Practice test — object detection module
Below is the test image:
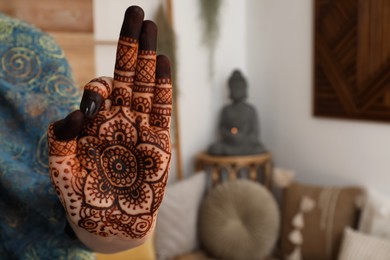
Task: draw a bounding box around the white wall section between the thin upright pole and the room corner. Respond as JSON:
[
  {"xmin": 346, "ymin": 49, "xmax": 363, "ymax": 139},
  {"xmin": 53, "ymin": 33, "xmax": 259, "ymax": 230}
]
[{"xmin": 173, "ymin": 0, "xmax": 246, "ymax": 175}]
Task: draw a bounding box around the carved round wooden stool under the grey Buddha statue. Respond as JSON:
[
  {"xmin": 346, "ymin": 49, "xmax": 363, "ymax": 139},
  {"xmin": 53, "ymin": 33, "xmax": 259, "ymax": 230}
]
[{"xmin": 195, "ymin": 152, "xmax": 272, "ymax": 189}]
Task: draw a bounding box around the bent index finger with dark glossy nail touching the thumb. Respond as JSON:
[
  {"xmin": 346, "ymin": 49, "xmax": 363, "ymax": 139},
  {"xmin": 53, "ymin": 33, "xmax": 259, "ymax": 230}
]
[{"xmin": 80, "ymin": 77, "xmax": 113, "ymax": 118}]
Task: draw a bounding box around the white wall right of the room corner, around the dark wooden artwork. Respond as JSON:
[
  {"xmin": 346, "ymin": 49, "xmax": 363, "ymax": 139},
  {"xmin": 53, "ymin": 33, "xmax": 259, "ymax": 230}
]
[{"xmin": 246, "ymin": 0, "xmax": 390, "ymax": 194}]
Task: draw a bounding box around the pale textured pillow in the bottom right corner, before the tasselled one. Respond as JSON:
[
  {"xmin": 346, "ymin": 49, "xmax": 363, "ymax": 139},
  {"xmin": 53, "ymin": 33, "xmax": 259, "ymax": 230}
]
[{"xmin": 338, "ymin": 228, "xmax": 390, "ymax": 260}]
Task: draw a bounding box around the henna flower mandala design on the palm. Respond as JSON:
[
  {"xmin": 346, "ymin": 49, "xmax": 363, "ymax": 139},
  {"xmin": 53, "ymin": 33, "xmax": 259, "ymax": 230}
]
[{"xmin": 77, "ymin": 107, "xmax": 170, "ymax": 238}]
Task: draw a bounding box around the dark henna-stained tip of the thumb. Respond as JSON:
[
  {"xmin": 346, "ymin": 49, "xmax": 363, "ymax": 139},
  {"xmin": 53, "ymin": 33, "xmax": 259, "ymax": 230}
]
[{"xmin": 52, "ymin": 110, "xmax": 84, "ymax": 141}]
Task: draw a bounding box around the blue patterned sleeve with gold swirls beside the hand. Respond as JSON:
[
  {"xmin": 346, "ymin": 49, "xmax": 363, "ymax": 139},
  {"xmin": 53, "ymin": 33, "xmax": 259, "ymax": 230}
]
[{"xmin": 0, "ymin": 13, "xmax": 94, "ymax": 259}]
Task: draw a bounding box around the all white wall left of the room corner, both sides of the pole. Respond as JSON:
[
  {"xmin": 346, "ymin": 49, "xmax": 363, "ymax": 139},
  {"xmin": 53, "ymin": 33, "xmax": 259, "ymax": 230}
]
[{"xmin": 94, "ymin": 0, "xmax": 247, "ymax": 179}]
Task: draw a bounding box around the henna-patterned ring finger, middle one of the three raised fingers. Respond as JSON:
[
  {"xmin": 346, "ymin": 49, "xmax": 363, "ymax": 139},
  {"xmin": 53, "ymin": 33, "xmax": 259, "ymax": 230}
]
[{"xmin": 132, "ymin": 21, "xmax": 157, "ymax": 116}]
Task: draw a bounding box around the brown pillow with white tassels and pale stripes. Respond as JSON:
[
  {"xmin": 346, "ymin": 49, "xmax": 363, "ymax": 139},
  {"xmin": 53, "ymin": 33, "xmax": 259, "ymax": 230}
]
[{"xmin": 281, "ymin": 183, "xmax": 364, "ymax": 260}]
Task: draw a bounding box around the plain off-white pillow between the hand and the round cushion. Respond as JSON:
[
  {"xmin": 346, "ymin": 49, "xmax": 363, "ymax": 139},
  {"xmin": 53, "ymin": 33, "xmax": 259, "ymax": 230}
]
[{"xmin": 155, "ymin": 172, "xmax": 207, "ymax": 260}]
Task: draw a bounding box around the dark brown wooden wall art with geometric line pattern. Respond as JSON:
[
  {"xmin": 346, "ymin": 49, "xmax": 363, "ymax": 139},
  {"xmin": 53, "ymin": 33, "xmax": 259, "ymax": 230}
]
[{"xmin": 314, "ymin": 0, "xmax": 390, "ymax": 121}]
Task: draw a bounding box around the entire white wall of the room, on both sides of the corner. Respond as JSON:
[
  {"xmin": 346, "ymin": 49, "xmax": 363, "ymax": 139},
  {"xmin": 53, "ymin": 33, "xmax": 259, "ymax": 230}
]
[{"xmin": 95, "ymin": 0, "xmax": 390, "ymax": 194}]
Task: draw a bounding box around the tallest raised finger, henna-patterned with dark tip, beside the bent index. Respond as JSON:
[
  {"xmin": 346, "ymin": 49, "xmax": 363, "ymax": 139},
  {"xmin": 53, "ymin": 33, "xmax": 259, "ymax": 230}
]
[{"xmin": 112, "ymin": 6, "xmax": 144, "ymax": 106}]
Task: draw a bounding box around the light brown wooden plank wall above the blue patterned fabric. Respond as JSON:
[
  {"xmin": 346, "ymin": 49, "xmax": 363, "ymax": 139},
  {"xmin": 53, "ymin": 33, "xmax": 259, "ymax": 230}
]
[{"xmin": 0, "ymin": 0, "xmax": 95, "ymax": 88}]
